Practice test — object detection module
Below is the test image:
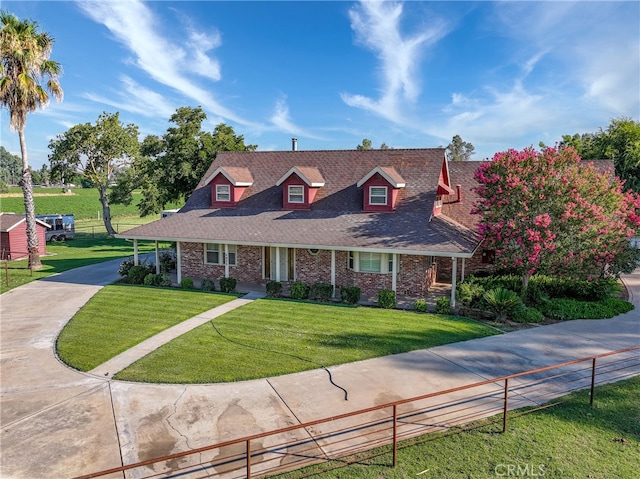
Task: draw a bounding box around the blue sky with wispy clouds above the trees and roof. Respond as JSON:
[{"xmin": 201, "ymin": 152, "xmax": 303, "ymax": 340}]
[{"xmin": 0, "ymin": 0, "xmax": 640, "ymax": 168}]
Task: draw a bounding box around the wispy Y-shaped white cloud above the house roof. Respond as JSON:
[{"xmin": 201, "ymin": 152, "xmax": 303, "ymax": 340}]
[{"xmin": 341, "ymin": 1, "xmax": 446, "ymax": 123}]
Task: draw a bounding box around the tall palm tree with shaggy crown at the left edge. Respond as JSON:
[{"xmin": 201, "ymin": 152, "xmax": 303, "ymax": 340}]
[{"xmin": 0, "ymin": 11, "xmax": 63, "ymax": 269}]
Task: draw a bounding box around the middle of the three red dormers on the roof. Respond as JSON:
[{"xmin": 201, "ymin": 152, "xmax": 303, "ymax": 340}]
[{"xmin": 276, "ymin": 166, "xmax": 324, "ymax": 210}]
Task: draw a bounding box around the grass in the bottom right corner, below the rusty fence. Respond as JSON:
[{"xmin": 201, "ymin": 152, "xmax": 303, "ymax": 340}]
[{"xmin": 271, "ymin": 377, "xmax": 640, "ymax": 479}]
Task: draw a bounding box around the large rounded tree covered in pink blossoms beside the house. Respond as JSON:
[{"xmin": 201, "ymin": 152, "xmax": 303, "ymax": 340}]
[{"xmin": 473, "ymin": 148, "xmax": 640, "ymax": 289}]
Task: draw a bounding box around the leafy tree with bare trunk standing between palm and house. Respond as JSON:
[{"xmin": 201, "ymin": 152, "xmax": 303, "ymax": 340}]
[{"xmin": 49, "ymin": 112, "xmax": 139, "ymax": 236}]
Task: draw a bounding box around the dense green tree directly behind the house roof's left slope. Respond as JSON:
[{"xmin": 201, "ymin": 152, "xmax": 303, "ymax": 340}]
[{"xmin": 112, "ymin": 107, "xmax": 256, "ymax": 216}]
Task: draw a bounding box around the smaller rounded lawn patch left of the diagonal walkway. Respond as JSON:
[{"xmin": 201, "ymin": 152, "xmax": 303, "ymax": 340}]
[{"xmin": 56, "ymin": 285, "xmax": 236, "ymax": 371}]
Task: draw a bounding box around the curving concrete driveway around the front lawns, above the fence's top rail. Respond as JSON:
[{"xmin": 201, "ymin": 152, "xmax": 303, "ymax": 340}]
[{"xmin": 0, "ymin": 261, "xmax": 640, "ymax": 479}]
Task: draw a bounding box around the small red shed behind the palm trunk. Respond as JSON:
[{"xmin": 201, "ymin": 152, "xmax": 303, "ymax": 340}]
[{"xmin": 0, "ymin": 213, "xmax": 49, "ymax": 260}]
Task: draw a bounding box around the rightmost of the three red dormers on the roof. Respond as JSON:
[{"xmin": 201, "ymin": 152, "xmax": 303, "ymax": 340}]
[{"xmin": 357, "ymin": 166, "xmax": 406, "ymax": 212}]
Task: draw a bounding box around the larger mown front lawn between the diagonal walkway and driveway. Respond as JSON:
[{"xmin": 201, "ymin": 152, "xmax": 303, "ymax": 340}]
[{"xmin": 115, "ymin": 299, "xmax": 498, "ymax": 383}]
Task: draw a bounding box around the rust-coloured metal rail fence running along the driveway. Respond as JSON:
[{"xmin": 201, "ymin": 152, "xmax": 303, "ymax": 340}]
[{"xmin": 74, "ymin": 346, "xmax": 640, "ymax": 479}]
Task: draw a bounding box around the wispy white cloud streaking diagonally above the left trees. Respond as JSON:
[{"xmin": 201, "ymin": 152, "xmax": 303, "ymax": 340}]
[{"xmin": 79, "ymin": 0, "xmax": 260, "ymax": 125}]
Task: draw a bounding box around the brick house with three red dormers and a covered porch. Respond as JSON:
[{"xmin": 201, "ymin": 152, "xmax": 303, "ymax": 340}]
[{"xmin": 118, "ymin": 148, "xmax": 480, "ymax": 303}]
